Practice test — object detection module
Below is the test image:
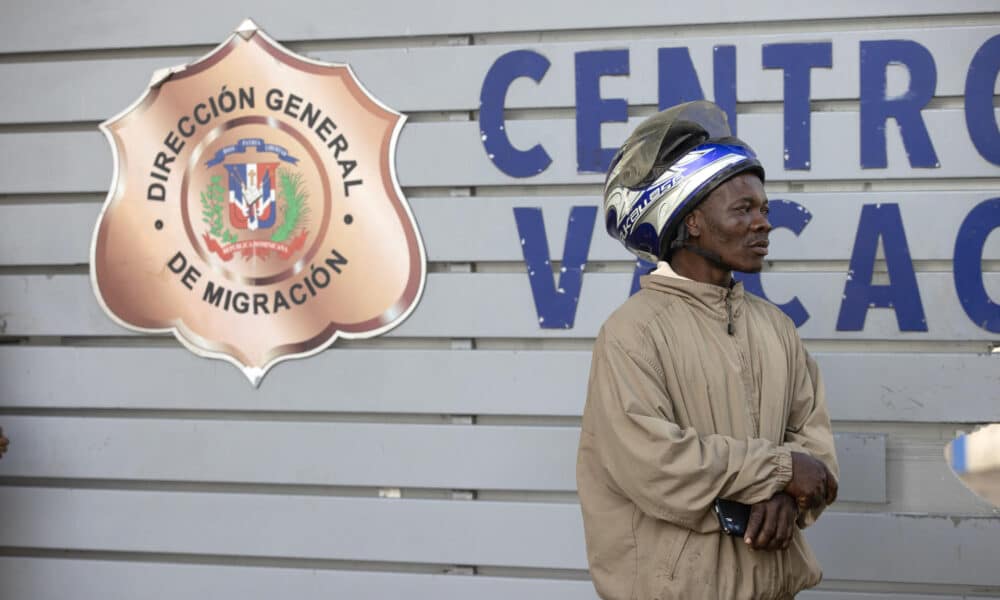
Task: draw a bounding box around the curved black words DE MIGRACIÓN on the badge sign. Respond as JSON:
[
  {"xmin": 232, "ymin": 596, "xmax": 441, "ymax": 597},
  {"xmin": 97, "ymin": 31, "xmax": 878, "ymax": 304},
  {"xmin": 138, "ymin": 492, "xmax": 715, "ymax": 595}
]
[{"xmin": 167, "ymin": 249, "xmax": 347, "ymax": 315}]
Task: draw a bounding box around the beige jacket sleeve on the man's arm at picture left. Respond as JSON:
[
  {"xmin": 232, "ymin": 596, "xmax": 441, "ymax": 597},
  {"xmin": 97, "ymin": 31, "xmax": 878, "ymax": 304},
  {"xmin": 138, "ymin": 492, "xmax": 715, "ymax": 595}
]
[{"xmin": 584, "ymin": 335, "xmax": 792, "ymax": 529}]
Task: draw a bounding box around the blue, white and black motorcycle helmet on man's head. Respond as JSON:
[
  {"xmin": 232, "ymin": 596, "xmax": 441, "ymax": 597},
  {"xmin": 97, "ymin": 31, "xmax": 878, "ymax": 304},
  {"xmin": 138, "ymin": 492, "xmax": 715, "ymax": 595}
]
[{"xmin": 604, "ymin": 100, "xmax": 764, "ymax": 263}]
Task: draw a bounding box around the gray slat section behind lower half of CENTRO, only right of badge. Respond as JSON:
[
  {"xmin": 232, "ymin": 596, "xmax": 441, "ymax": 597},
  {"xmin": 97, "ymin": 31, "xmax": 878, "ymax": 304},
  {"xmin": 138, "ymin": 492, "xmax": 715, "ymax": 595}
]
[{"xmin": 394, "ymin": 109, "xmax": 1000, "ymax": 186}]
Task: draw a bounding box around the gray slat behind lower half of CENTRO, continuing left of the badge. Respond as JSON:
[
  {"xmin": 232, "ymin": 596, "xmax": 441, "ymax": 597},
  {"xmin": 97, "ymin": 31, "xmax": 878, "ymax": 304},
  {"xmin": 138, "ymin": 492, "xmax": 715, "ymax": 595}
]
[{"xmin": 0, "ymin": 109, "xmax": 1000, "ymax": 194}]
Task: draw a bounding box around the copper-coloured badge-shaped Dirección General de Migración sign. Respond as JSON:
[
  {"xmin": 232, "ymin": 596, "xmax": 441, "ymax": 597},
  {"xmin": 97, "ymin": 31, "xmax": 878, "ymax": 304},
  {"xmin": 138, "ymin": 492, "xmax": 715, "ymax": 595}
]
[{"xmin": 91, "ymin": 21, "xmax": 426, "ymax": 384}]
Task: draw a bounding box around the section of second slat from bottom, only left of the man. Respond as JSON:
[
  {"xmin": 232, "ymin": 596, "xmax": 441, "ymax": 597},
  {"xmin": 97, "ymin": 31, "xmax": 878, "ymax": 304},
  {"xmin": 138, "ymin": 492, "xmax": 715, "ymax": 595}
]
[{"xmin": 0, "ymin": 486, "xmax": 586, "ymax": 569}]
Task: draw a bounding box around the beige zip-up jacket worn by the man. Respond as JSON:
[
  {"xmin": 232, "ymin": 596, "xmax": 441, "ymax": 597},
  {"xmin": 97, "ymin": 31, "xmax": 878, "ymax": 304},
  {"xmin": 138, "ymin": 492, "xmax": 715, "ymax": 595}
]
[{"xmin": 577, "ymin": 274, "xmax": 838, "ymax": 600}]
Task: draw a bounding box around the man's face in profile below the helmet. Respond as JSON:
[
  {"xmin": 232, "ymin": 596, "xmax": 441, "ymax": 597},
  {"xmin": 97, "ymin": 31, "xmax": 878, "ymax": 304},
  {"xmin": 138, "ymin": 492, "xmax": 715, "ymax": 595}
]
[{"xmin": 687, "ymin": 173, "xmax": 771, "ymax": 273}]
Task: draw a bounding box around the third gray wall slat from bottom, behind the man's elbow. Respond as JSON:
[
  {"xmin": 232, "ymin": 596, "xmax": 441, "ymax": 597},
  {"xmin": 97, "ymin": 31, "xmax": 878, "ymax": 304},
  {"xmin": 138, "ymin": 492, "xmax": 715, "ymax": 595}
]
[{"xmin": 0, "ymin": 416, "xmax": 885, "ymax": 503}]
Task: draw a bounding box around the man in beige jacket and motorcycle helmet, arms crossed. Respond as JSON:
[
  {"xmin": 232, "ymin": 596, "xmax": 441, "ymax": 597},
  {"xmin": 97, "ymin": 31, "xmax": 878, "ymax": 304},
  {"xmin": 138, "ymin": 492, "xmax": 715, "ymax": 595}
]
[{"xmin": 577, "ymin": 101, "xmax": 838, "ymax": 600}]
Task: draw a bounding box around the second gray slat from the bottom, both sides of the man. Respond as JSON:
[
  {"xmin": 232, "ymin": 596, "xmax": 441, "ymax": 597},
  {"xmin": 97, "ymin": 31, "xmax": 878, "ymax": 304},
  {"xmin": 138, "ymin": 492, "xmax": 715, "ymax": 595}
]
[{"xmin": 0, "ymin": 487, "xmax": 1000, "ymax": 586}]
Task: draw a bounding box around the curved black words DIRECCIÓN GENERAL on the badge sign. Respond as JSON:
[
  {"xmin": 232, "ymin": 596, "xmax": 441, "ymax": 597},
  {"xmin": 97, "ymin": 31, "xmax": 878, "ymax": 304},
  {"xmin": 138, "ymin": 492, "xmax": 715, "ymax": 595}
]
[{"xmin": 146, "ymin": 86, "xmax": 364, "ymax": 202}]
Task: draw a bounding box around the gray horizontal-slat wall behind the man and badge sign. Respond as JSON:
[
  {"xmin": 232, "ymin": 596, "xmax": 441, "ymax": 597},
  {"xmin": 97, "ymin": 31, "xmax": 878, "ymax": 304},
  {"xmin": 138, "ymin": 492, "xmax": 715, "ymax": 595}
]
[{"xmin": 0, "ymin": 0, "xmax": 1000, "ymax": 600}]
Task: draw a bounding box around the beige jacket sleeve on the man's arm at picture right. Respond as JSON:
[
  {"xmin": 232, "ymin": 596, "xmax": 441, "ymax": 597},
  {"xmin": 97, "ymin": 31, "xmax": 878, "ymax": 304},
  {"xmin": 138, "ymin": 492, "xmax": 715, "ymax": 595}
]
[{"xmin": 785, "ymin": 340, "xmax": 840, "ymax": 527}]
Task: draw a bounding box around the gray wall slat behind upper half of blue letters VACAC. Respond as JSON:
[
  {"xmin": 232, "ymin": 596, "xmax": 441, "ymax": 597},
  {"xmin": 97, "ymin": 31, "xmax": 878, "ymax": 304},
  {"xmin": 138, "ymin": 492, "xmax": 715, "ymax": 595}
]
[{"xmin": 0, "ymin": 191, "xmax": 1000, "ymax": 266}]
